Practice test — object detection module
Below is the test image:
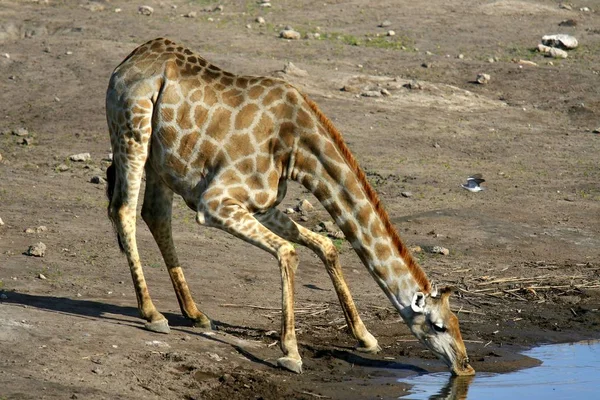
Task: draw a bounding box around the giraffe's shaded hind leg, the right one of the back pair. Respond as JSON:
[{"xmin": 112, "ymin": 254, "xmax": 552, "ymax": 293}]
[{"xmin": 142, "ymin": 164, "xmax": 211, "ymax": 328}]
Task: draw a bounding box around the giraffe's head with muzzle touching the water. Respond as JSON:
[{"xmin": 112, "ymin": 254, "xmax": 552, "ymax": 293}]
[{"xmin": 408, "ymin": 287, "xmax": 475, "ymax": 375}]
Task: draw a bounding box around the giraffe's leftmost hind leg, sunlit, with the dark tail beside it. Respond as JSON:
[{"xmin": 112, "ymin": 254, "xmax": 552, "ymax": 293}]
[{"xmin": 107, "ymin": 102, "xmax": 170, "ymax": 333}]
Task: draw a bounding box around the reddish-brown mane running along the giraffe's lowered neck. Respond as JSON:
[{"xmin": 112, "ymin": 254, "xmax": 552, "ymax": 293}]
[{"xmin": 302, "ymin": 94, "xmax": 431, "ymax": 293}]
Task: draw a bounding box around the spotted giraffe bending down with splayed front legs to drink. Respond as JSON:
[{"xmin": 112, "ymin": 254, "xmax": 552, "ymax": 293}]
[{"xmin": 106, "ymin": 38, "xmax": 474, "ymax": 375}]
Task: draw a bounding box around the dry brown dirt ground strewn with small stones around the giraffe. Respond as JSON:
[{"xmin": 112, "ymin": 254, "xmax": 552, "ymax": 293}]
[{"xmin": 0, "ymin": 0, "xmax": 600, "ymax": 399}]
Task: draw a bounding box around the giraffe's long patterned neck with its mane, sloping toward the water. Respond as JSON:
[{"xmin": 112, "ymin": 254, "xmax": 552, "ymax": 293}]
[{"xmin": 292, "ymin": 98, "xmax": 431, "ymax": 311}]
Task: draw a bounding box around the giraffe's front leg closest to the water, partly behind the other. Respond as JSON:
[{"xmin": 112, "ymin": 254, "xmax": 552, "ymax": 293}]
[{"xmin": 260, "ymin": 208, "xmax": 381, "ymax": 353}]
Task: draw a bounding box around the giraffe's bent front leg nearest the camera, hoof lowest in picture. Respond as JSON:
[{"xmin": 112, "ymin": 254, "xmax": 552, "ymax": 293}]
[{"xmin": 204, "ymin": 202, "xmax": 302, "ymax": 373}]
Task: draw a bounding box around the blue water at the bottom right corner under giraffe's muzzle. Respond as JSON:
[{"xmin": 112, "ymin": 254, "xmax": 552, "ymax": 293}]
[{"xmin": 399, "ymin": 341, "xmax": 600, "ymax": 400}]
